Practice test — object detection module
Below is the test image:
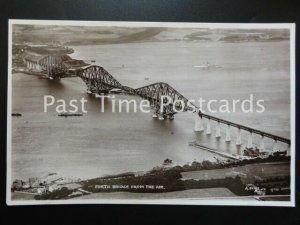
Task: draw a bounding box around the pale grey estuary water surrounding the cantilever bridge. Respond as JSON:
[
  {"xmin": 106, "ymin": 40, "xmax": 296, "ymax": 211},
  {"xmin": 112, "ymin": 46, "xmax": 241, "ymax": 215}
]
[{"xmin": 12, "ymin": 41, "xmax": 290, "ymax": 179}]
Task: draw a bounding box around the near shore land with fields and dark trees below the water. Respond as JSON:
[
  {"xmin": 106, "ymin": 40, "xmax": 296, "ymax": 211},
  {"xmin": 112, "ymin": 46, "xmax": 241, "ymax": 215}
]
[{"xmin": 14, "ymin": 156, "xmax": 290, "ymax": 200}]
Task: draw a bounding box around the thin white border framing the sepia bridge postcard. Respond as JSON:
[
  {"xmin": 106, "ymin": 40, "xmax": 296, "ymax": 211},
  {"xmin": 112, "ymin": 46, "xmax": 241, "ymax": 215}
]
[{"xmin": 6, "ymin": 19, "xmax": 296, "ymax": 207}]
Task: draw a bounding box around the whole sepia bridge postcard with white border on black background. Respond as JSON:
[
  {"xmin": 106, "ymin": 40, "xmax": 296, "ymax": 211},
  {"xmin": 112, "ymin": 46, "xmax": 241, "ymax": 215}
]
[{"xmin": 7, "ymin": 20, "xmax": 295, "ymax": 206}]
